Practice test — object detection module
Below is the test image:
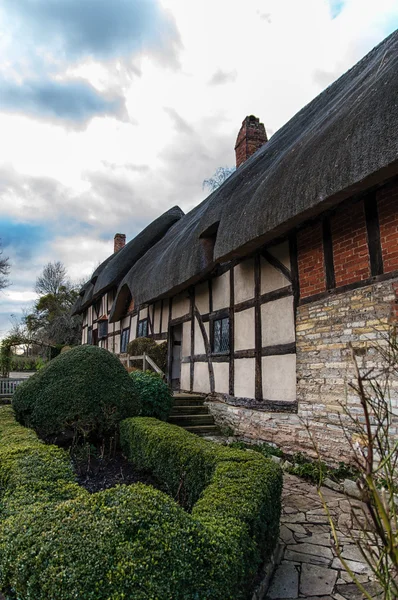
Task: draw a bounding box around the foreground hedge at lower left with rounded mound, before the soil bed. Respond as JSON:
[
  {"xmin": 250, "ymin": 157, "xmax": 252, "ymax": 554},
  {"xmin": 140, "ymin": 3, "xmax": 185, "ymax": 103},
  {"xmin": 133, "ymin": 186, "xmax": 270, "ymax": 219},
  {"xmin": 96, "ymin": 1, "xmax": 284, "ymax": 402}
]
[{"xmin": 0, "ymin": 407, "xmax": 211, "ymax": 600}]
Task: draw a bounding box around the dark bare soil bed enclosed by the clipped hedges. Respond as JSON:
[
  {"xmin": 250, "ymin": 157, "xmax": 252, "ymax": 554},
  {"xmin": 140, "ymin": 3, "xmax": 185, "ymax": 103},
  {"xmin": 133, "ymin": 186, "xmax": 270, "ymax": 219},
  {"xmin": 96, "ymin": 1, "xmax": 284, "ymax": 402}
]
[{"xmin": 72, "ymin": 449, "xmax": 164, "ymax": 493}]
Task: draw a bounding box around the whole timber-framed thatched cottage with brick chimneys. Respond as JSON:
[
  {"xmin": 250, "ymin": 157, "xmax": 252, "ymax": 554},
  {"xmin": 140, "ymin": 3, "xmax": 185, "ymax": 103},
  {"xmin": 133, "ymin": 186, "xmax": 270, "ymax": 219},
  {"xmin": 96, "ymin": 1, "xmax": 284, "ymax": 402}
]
[{"xmin": 75, "ymin": 33, "xmax": 398, "ymax": 460}]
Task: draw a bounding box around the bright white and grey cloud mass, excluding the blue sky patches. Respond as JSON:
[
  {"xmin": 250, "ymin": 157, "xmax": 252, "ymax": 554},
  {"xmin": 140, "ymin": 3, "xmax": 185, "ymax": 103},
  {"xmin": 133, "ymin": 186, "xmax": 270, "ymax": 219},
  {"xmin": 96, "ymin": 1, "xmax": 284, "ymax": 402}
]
[{"xmin": 0, "ymin": 0, "xmax": 398, "ymax": 338}]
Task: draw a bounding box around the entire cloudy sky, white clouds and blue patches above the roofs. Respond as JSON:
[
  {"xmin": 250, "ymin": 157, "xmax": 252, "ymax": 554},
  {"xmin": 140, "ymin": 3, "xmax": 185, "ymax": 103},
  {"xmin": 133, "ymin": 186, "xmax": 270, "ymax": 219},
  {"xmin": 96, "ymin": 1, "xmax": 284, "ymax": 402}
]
[{"xmin": 0, "ymin": 0, "xmax": 398, "ymax": 337}]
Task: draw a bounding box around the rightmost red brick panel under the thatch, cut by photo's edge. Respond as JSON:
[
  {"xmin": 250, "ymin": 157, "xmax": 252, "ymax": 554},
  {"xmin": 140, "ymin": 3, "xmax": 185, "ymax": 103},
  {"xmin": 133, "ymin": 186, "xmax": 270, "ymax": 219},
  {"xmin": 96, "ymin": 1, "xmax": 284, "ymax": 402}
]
[{"xmin": 377, "ymin": 181, "xmax": 398, "ymax": 273}]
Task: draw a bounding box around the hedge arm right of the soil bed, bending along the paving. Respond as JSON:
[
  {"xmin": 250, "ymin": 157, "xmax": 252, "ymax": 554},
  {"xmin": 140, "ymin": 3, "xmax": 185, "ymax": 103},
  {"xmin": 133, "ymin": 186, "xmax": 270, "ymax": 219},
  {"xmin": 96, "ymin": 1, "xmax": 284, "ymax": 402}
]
[{"xmin": 120, "ymin": 417, "xmax": 282, "ymax": 598}]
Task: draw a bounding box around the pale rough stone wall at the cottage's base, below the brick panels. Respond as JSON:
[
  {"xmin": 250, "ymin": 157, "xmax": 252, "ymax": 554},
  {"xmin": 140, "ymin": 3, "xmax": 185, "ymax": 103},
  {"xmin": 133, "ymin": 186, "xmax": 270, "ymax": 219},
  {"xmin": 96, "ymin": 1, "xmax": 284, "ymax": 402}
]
[{"xmin": 209, "ymin": 280, "xmax": 398, "ymax": 462}]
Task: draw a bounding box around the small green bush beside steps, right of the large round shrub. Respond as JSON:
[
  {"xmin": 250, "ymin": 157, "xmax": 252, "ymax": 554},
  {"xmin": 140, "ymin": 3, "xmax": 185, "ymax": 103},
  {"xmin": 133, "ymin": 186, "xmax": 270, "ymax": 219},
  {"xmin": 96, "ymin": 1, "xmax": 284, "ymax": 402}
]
[{"xmin": 130, "ymin": 371, "xmax": 173, "ymax": 421}]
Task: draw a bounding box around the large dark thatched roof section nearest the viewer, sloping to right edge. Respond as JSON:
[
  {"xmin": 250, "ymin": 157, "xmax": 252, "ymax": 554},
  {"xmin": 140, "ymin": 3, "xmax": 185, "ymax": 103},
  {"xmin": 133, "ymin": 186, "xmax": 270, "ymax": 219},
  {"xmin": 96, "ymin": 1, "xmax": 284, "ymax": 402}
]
[{"xmin": 115, "ymin": 32, "xmax": 398, "ymax": 305}]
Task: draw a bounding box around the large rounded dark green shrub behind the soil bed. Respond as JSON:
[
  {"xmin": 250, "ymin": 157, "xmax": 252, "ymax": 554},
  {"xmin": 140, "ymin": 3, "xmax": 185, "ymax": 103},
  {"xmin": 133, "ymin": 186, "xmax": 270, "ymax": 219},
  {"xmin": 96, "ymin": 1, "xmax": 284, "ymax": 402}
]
[{"xmin": 12, "ymin": 346, "xmax": 141, "ymax": 438}]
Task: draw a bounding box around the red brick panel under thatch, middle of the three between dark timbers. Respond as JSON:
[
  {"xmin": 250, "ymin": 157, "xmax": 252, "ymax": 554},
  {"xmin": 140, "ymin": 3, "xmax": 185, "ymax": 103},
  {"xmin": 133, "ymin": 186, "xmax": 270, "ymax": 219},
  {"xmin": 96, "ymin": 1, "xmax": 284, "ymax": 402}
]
[{"xmin": 331, "ymin": 202, "xmax": 370, "ymax": 287}]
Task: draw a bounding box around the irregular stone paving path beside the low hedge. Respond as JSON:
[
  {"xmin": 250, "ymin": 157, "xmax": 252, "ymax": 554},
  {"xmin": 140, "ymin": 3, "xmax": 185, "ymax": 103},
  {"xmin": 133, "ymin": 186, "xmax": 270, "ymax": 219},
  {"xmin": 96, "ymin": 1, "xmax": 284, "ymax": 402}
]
[{"xmin": 266, "ymin": 474, "xmax": 380, "ymax": 600}]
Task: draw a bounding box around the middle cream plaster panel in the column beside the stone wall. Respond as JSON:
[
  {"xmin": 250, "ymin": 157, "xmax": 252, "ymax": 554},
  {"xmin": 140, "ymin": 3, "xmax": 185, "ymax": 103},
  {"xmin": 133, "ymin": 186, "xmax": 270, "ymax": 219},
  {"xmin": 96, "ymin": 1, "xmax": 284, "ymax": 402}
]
[{"xmin": 261, "ymin": 296, "xmax": 295, "ymax": 346}]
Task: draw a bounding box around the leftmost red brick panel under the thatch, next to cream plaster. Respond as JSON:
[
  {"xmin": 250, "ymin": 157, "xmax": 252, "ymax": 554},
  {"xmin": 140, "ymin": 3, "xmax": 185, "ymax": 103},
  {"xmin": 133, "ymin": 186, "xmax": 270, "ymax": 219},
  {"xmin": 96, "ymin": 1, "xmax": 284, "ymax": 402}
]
[{"xmin": 297, "ymin": 223, "xmax": 326, "ymax": 298}]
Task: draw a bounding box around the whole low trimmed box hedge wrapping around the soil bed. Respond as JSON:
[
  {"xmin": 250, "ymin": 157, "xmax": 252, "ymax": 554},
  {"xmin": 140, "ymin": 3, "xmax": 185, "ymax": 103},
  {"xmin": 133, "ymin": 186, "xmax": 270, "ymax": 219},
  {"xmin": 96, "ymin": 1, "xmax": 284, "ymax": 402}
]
[{"xmin": 0, "ymin": 407, "xmax": 281, "ymax": 600}]
